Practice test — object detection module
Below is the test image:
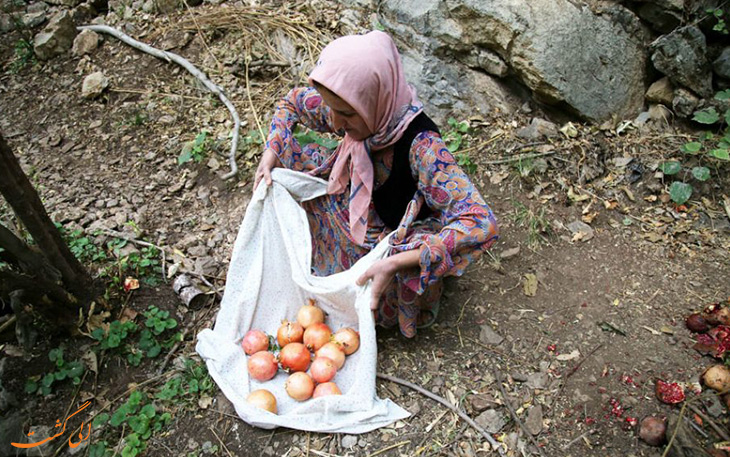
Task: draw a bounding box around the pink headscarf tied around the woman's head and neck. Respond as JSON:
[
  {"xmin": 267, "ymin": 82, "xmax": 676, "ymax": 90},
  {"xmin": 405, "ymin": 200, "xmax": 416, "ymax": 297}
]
[{"xmin": 309, "ymin": 31, "xmax": 423, "ymax": 244}]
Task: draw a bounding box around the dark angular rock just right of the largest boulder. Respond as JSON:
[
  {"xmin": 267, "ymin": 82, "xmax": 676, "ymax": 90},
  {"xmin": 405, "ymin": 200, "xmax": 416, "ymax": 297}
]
[{"xmin": 650, "ymin": 26, "xmax": 712, "ymax": 97}]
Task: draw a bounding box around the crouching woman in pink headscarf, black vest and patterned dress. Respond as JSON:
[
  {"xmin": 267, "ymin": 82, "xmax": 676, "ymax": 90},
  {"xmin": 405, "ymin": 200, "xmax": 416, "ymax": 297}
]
[{"xmin": 255, "ymin": 31, "xmax": 497, "ymax": 337}]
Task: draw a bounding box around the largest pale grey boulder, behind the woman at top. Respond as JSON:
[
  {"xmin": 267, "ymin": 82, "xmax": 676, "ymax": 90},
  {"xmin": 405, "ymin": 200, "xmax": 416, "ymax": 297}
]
[{"xmin": 381, "ymin": 0, "xmax": 646, "ymax": 121}]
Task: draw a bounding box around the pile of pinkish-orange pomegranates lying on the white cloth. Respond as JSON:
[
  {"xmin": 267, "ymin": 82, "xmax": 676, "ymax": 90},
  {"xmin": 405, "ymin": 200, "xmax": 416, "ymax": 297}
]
[{"xmin": 241, "ymin": 299, "xmax": 360, "ymax": 414}]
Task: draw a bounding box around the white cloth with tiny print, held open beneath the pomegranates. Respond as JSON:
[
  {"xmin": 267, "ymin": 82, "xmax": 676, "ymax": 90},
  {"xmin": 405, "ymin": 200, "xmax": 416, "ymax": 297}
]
[{"xmin": 196, "ymin": 168, "xmax": 409, "ymax": 433}]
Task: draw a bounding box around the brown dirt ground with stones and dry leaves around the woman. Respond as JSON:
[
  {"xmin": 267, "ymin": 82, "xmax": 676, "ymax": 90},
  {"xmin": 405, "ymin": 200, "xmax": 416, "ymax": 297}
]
[{"xmin": 0, "ymin": 1, "xmax": 730, "ymax": 457}]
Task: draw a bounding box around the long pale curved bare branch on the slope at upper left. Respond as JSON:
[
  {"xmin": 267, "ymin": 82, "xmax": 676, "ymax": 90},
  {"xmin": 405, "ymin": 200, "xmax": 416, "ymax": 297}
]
[{"xmin": 77, "ymin": 25, "xmax": 241, "ymax": 180}]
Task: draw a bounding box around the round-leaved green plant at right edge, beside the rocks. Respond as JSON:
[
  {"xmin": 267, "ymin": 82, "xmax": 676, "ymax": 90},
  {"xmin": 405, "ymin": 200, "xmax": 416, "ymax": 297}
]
[{"xmin": 660, "ymin": 89, "xmax": 730, "ymax": 205}]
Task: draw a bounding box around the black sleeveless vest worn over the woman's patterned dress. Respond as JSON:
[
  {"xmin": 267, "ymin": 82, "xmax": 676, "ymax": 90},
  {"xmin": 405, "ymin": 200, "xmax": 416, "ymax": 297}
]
[{"xmin": 372, "ymin": 112, "xmax": 440, "ymax": 230}]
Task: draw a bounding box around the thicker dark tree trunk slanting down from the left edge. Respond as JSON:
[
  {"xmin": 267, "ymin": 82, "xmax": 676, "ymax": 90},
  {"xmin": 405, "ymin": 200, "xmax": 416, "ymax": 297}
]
[{"xmin": 0, "ymin": 135, "xmax": 94, "ymax": 303}]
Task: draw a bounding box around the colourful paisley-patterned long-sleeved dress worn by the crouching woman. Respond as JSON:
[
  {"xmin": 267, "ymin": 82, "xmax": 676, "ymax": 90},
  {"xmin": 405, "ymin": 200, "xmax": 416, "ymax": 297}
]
[{"xmin": 266, "ymin": 87, "xmax": 498, "ymax": 338}]
